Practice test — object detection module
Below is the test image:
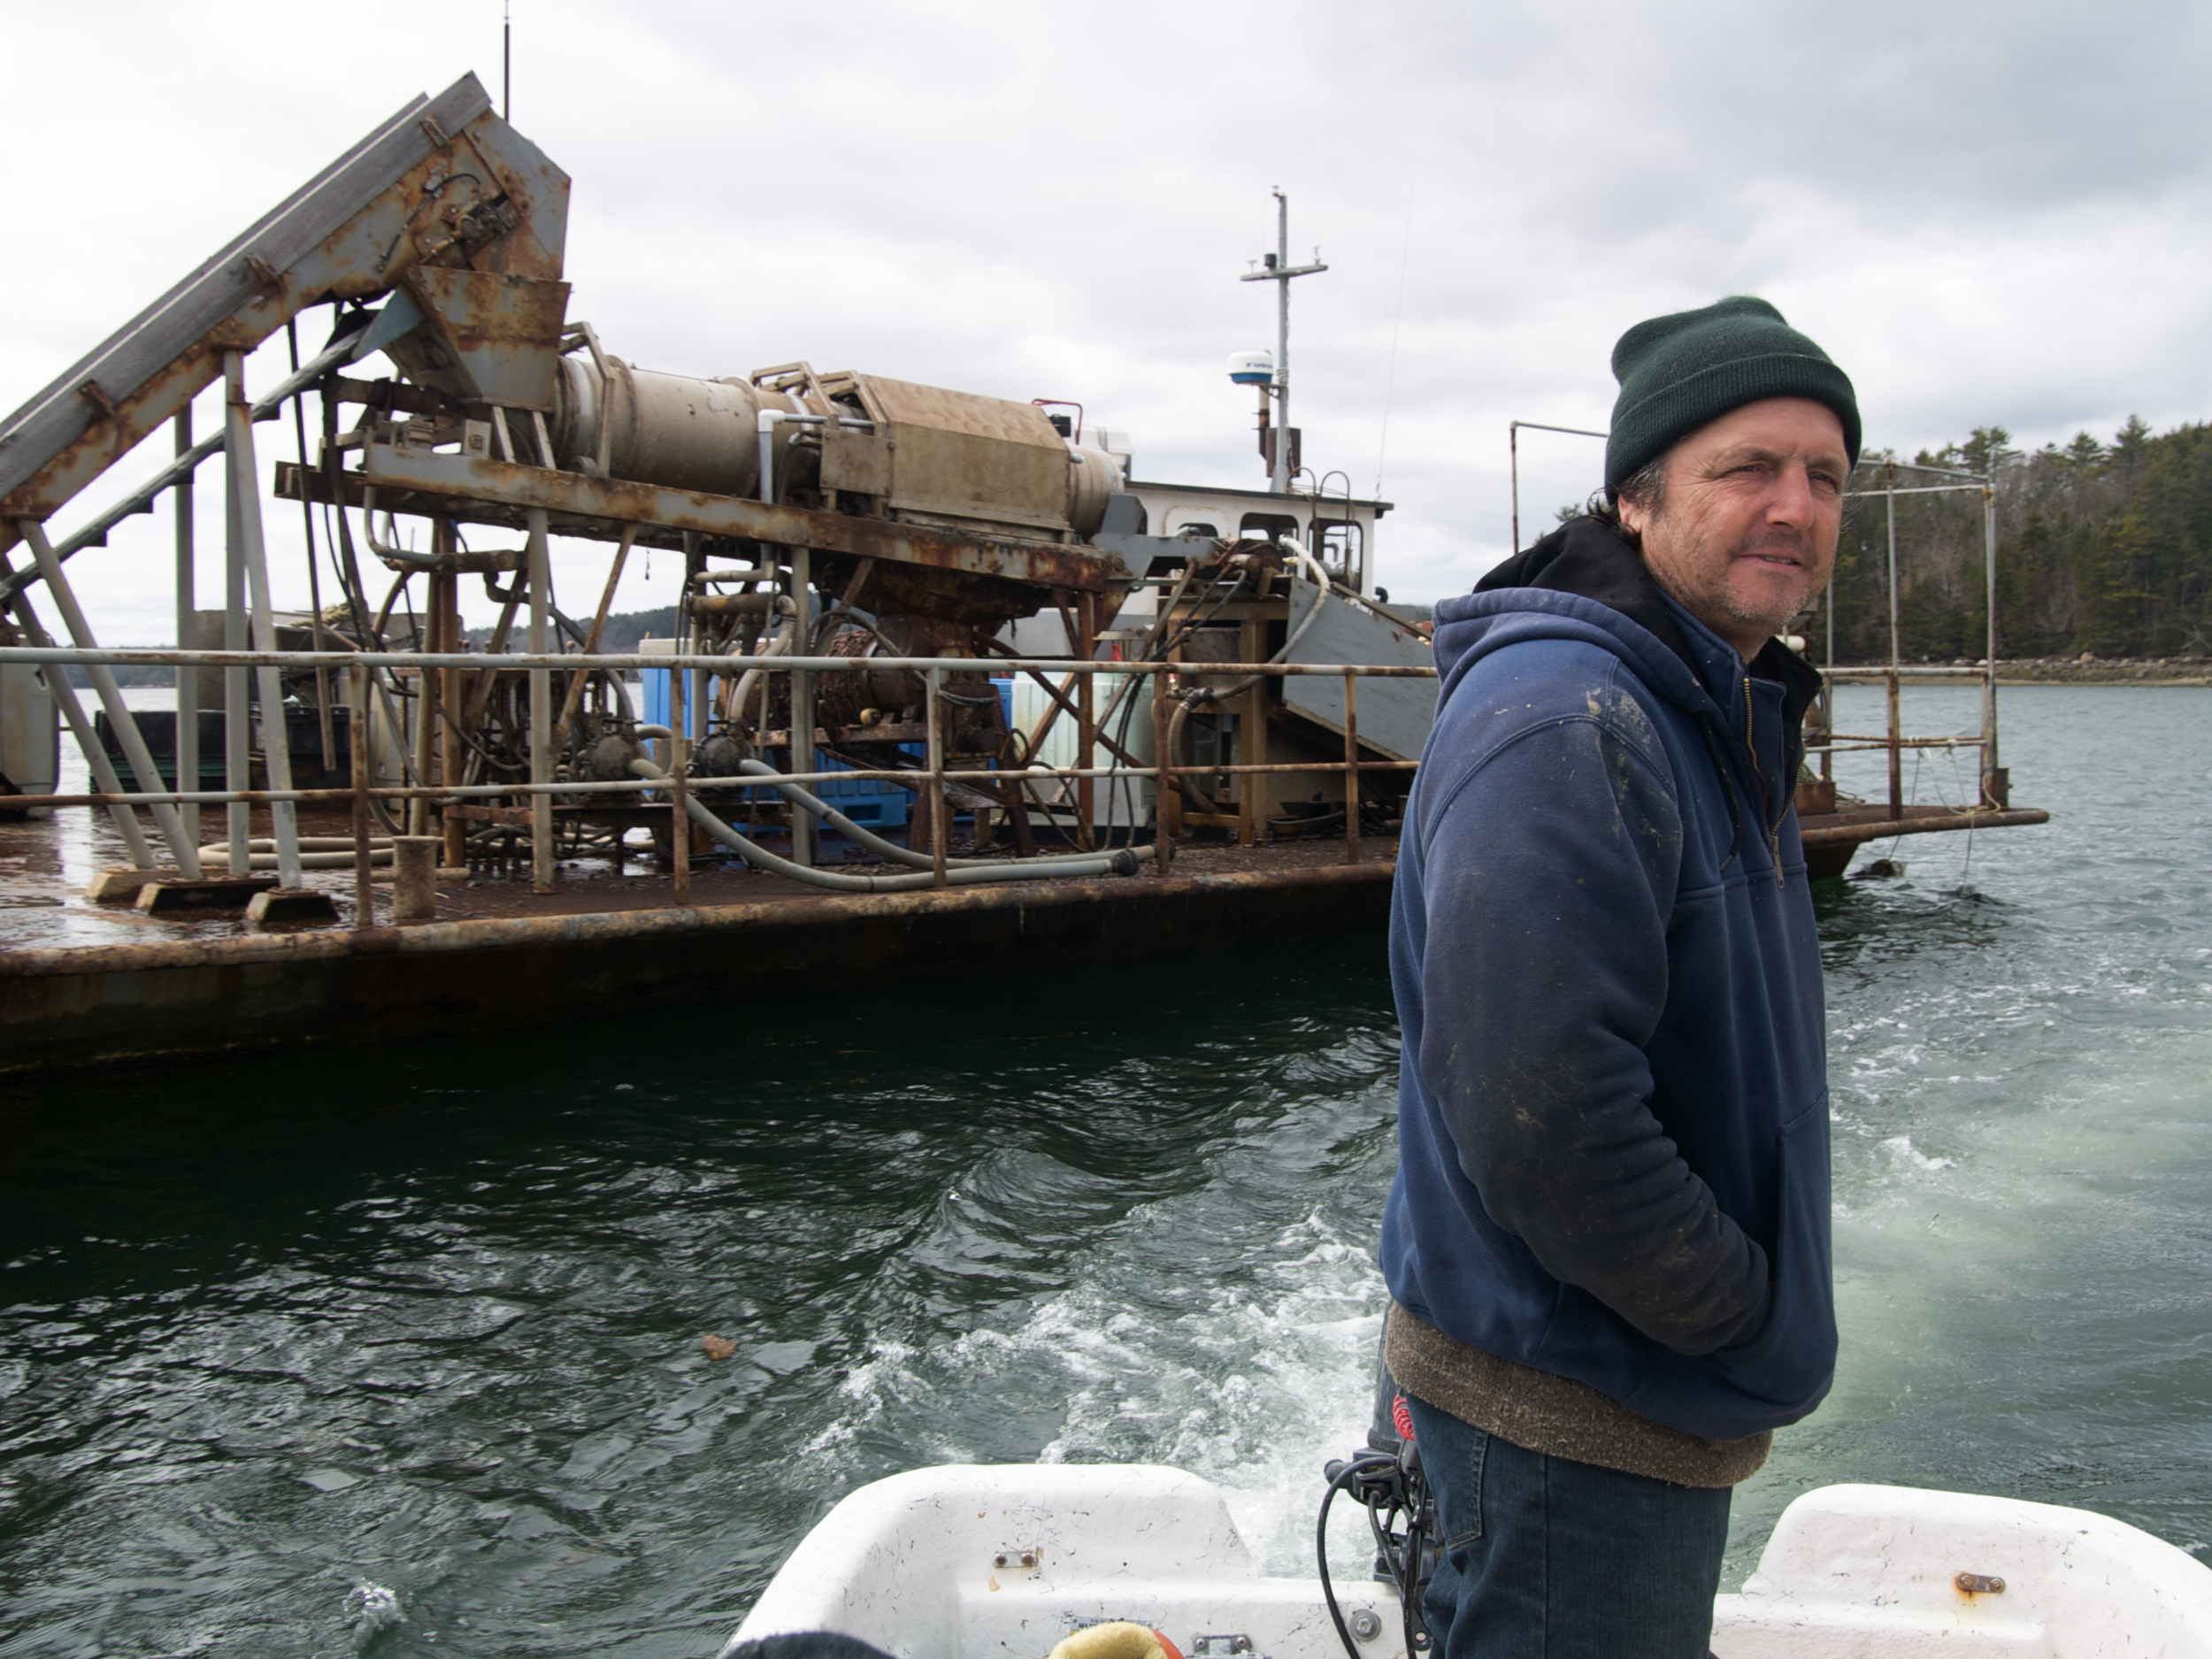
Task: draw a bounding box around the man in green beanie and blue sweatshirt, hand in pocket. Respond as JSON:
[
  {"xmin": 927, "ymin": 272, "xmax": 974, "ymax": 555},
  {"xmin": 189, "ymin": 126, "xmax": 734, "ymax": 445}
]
[{"xmin": 1383, "ymin": 299, "xmax": 1858, "ymax": 1659}]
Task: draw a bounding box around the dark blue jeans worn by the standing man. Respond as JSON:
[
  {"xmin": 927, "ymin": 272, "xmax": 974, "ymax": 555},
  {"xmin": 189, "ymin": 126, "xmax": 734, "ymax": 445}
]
[{"xmin": 1409, "ymin": 1401, "xmax": 1730, "ymax": 1659}]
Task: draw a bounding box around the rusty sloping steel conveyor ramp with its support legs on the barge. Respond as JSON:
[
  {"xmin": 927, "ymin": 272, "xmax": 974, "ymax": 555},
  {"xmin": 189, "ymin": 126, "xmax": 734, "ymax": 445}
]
[{"xmin": 0, "ymin": 75, "xmax": 569, "ymax": 889}]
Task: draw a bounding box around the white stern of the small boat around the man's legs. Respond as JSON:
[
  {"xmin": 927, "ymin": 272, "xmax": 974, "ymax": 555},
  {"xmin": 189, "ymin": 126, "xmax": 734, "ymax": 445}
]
[{"xmin": 724, "ymin": 1464, "xmax": 2212, "ymax": 1659}]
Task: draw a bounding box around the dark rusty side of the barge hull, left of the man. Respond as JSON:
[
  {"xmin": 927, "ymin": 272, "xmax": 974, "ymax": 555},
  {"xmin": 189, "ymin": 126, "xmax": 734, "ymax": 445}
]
[{"xmin": 0, "ymin": 861, "xmax": 1392, "ymax": 1078}]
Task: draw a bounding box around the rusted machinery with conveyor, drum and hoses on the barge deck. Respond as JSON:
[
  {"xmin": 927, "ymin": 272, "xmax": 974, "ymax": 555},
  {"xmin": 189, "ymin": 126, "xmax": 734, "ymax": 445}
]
[{"xmin": 0, "ymin": 78, "xmax": 1429, "ymax": 925}]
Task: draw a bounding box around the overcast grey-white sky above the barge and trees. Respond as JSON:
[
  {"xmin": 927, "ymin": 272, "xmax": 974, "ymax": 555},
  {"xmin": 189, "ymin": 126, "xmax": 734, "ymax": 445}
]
[{"xmin": 0, "ymin": 0, "xmax": 2212, "ymax": 644}]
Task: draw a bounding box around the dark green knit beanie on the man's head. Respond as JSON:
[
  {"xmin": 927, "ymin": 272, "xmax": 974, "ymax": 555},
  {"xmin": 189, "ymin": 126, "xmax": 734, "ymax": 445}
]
[{"xmin": 1606, "ymin": 295, "xmax": 1858, "ymax": 489}]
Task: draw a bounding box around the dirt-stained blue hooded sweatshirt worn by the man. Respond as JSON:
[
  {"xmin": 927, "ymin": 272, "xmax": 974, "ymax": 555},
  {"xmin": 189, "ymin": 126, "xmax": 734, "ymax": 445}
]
[{"xmin": 1383, "ymin": 518, "xmax": 1836, "ymax": 1440}]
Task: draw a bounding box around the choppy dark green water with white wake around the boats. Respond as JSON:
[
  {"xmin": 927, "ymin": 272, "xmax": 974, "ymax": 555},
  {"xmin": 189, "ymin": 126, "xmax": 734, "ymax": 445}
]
[{"xmin": 0, "ymin": 688, "xmax": 2212, "ymax": 1659}]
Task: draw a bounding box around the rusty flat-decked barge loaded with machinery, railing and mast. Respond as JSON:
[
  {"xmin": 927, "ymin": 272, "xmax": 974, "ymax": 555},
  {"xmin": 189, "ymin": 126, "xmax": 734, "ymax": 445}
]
[{"xmin": 0, "ymin": 78, "xmax": 2044, "ymax": 1075}]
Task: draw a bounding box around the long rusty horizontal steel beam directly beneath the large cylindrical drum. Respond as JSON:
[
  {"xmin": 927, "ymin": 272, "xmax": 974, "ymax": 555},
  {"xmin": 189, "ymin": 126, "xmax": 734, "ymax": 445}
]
[{"xmin": 351, "ymin": 445, "xmax": 1128, "ymax": 593}]
